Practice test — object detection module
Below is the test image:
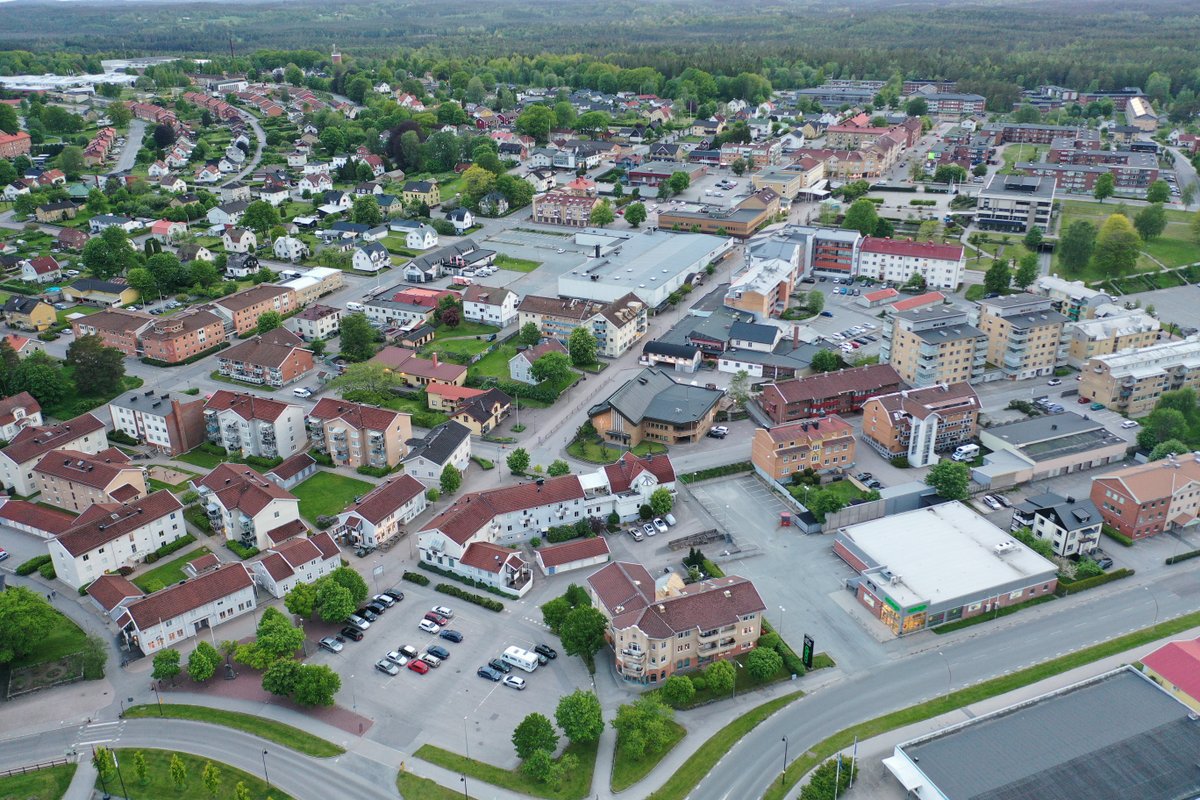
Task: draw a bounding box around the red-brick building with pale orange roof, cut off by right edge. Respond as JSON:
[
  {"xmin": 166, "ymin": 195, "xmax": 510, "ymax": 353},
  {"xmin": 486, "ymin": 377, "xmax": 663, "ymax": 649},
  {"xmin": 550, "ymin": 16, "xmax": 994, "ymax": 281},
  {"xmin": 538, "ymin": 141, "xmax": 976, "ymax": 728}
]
[{"xmin": 1091, "ymin": 453, "xmax": 1200, "ymax": 540}]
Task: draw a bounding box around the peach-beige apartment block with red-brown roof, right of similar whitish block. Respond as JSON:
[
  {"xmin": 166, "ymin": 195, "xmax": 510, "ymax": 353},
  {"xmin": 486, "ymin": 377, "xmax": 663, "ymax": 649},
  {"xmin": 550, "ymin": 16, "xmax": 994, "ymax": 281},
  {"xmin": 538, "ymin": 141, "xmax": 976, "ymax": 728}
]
[{"xmin": 305, "ymin": 397, "xmax": 413, "ymax": 468}]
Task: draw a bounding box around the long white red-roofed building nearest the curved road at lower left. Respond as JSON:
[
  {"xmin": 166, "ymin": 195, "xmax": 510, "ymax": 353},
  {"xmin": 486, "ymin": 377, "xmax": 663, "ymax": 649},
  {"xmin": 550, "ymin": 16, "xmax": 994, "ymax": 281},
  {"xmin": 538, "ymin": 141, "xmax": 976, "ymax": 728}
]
[{"xmin": 116, "ymin": 564, "xmax": 258, "ymax": 656}]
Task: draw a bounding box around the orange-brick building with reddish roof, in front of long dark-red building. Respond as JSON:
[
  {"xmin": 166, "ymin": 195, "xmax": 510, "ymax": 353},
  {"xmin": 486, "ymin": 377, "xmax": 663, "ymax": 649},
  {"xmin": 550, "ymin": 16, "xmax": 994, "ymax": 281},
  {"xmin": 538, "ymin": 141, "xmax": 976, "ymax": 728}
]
[{"xmin": 750, "ymin": 414, "xmax": 854, "ymax": 482}]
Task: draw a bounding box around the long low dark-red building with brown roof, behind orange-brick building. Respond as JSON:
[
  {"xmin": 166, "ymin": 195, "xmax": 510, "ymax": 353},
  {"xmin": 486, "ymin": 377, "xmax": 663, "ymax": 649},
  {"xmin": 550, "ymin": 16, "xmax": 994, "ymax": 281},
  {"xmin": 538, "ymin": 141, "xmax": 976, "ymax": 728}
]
[{"xmin": 758, "ymin": 363, "xmax": 900, "ymax": 425}]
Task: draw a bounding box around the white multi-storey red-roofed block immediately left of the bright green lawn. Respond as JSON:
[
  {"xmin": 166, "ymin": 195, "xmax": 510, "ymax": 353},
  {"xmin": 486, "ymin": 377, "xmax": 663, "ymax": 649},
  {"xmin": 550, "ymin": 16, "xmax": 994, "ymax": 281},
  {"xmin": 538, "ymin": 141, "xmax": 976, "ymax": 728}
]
[{"xmin": 192, "ymin": 464, "xmax": 304, "ymax": 551}]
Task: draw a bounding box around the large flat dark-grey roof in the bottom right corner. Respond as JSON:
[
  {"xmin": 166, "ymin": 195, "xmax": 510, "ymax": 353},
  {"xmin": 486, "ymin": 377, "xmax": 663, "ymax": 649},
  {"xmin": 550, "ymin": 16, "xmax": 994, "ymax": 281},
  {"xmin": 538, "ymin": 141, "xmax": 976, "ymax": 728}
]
[{"xmin": 900, "ymin": 667, "xmax": 1200, "ymax": 800}]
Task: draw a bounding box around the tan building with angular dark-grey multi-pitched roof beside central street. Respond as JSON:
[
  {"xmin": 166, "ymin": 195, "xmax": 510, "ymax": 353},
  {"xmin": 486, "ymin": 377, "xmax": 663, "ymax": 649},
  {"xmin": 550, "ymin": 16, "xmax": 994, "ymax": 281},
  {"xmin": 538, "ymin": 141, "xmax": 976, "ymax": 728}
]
[{"xmin": 588, "ymin": 367, "xmax": 725, "ymax": 447}]
